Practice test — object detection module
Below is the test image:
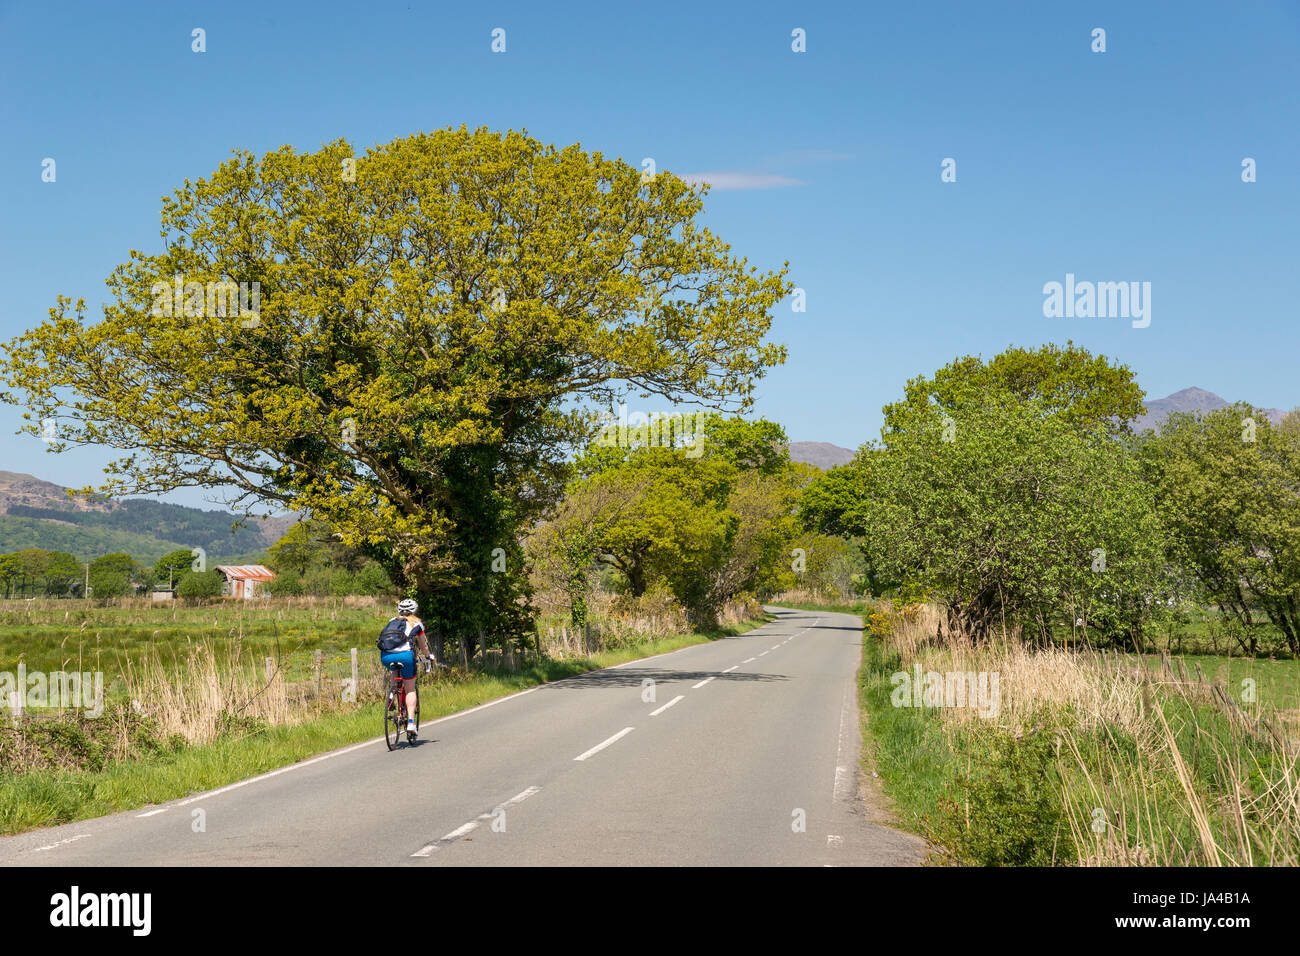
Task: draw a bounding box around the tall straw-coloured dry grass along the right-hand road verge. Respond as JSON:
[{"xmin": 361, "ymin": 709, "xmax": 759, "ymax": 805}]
[{"xmin": 868, "ymin": 604, "xmax": 1300, "ymax": 866}]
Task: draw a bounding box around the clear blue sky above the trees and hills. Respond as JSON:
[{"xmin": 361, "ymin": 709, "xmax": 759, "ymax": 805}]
[{"xmin": 0, "ymin": 0, "xmax": 1300, "ymax": 505}]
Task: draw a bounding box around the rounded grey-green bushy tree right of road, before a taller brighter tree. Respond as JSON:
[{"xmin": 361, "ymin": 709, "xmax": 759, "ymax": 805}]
[{"xmin": 802, "ymin": 392, "xmax": 1177, "ymax": 641}]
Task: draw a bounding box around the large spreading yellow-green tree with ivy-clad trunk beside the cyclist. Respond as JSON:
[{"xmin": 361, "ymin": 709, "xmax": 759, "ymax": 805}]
[{"xmin": 0, "ymin": 127, "xmax": 792, "ymax": 631}]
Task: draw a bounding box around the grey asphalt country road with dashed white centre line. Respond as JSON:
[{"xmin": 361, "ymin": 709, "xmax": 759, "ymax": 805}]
[{"xmin": 0, "ymin": 609, "xmax": 924, "ymax": 866}]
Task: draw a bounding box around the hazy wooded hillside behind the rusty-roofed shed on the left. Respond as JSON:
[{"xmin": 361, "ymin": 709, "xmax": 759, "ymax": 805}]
[{"xmin": 0, "ymin": 471, "xmax": 295, "ymax": 562}]
